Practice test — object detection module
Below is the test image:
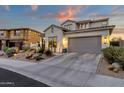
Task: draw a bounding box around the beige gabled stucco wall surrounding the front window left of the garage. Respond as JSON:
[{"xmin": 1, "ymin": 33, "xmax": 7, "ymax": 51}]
[{"xmin": 45, "ymin": 26, "xmax": 63, "ymax": 52}]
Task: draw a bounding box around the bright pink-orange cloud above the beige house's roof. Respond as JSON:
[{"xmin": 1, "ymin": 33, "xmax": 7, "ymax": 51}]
[{"xmin": 56, "ymin": 6, "xmax": 86, "ymax": 21}]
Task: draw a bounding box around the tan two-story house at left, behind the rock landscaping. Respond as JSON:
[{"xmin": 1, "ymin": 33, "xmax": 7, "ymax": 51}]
[{"xmin": 0, "ymin": 28, "xmax": 43, "ymax": 50}]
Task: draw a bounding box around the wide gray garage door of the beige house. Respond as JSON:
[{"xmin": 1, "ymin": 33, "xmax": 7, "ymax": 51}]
[{"xmin": 68, "ymin": 36, "xmax": 101, "ymax": 53}]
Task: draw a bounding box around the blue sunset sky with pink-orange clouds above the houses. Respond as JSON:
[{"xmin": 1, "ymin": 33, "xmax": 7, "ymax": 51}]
[{"xmin": 0, "ymin": 5, "xmax": 124, "ymax": 32}]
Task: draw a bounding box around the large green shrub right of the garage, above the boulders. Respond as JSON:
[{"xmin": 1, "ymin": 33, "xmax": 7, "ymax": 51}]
[{"xmin": 103, "ymin": 46, "xmax": 124, "ymax": 65}]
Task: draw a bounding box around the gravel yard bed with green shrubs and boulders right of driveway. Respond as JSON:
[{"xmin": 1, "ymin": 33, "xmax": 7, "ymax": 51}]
[{"xmin": 97, "ymin": 46, "xmax": 124, "ymax": 79}]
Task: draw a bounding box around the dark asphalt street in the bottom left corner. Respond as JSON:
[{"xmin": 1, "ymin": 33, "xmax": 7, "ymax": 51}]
[{"xmin": 0, "ymin": 68, "xmax": 48, "ymax": 87}]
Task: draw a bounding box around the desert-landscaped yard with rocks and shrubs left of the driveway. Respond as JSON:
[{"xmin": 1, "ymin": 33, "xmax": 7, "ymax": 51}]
[{"xmin": 0, "ymin": 47, "xmax": 55, "ymax": 62}]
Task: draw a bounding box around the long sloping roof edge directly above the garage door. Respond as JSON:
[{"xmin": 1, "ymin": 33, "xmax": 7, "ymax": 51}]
[{"xmin": 65, "ymin": 25, "xmax": 115, "ymax": 35}]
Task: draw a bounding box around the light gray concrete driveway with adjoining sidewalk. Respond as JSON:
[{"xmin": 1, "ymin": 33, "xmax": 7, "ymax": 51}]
[{"xmin": 0, "ymin": 53, "xmax": 124, "ymax": 87}]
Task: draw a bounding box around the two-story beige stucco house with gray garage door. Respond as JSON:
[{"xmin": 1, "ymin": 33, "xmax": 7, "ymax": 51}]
[{"xmin": 44, "ymin": 18, "xmax": 115, "ymax": 53}]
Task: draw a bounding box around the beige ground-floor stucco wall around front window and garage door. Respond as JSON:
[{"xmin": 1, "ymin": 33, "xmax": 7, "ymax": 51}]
[{"xmin": 45, "ymin": 26, "xmax": 110, "ymax": 52}]
